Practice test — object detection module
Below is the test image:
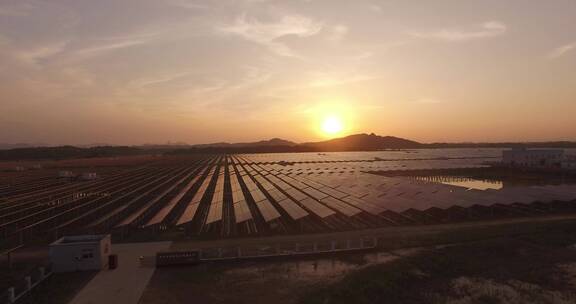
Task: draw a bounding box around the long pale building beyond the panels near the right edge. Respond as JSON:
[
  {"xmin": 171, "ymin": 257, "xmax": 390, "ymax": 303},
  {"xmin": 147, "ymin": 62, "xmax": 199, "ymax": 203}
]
[{"xmin": 502, "ymin": 148, "xmax": 565, "ymax": 169}]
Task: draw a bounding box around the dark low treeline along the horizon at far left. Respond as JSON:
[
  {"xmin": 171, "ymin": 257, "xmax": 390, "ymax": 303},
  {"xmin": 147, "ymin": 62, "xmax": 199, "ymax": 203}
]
[{"xmin": 0, "ymin": 146, "xmax": 149, "ymax": 160}]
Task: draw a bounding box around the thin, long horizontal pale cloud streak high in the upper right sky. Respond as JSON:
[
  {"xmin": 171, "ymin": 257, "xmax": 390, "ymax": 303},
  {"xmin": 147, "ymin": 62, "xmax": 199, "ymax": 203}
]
[{"xmin": 411, "ymin": 21, "xmax": 508, "ymax": 42}]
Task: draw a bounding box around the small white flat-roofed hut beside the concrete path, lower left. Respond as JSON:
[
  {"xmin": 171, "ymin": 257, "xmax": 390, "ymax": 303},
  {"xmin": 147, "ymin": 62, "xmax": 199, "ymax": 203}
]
[{"xmin": 50, "ymin": 235, "xmax": 112, "ymax": 272}]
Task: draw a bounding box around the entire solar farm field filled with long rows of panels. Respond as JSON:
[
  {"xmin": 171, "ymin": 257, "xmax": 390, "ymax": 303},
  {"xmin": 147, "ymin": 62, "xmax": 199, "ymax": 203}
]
[{"xmin": 0, "ymin": 149, "xmax": 576, "ymax": 249}]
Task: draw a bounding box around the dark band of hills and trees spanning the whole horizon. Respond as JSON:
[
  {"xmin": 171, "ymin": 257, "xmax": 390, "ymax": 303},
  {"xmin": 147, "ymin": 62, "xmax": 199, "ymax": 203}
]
[{"xmin": 0, "ymin": 133, "xmax": 576, "ymax": 160}]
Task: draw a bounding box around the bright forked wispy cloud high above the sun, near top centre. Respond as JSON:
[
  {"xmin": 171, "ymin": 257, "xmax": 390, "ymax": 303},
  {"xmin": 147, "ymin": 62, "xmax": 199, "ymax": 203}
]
[{"xmin": 219, "ymin": 15, "xmax": 323, "ymax": 57}]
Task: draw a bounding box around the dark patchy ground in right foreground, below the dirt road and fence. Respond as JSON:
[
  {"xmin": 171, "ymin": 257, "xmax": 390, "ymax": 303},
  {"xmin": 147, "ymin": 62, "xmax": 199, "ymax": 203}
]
[{"xmin": 140, "ymin": 217, "xmax": 576, "ymax": 304}]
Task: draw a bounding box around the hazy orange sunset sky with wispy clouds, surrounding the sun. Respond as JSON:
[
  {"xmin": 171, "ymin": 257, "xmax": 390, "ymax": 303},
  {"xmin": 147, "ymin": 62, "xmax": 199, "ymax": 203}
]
[{"xmin": 0, "ymin": 0, "xmax": 576, "ymax": 144}]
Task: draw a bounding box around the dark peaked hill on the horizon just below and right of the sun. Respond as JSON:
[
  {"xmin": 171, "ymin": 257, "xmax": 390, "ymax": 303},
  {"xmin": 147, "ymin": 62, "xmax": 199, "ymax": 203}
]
[{"xmin": 301, "ymin": 133, "xmax": 424, "ymax": 151}]
